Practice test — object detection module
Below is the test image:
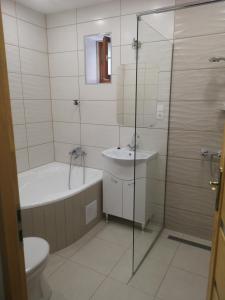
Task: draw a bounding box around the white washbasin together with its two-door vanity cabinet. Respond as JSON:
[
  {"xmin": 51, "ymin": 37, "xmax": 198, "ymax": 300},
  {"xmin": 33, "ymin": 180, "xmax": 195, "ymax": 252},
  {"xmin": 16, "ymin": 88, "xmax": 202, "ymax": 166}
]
[{"xmin": 102, "ymin": 148, "xmax": 157, "ymax": 228}]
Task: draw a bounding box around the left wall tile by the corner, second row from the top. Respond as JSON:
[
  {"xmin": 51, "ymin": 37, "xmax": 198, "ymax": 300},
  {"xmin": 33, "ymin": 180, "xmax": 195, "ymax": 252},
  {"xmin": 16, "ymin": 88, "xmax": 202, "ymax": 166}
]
[{"xmin": 18, "ymin": 20, "xmax": 47, "ymax": 52}]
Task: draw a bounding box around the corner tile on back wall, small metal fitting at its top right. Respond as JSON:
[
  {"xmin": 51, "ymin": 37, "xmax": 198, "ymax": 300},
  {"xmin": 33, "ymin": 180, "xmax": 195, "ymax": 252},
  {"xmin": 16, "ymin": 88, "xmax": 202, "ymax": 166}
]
[{"xmin": 52, "ymin": 100, "xmax": 80, "ymax": 123}]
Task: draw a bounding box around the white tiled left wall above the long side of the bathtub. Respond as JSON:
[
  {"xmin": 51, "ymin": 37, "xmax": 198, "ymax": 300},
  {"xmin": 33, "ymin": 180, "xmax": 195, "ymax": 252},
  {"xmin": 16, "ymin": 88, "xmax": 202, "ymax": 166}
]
[{"xmin": 1, "ymin": 0, "xmax": 54, "ymax": 172}]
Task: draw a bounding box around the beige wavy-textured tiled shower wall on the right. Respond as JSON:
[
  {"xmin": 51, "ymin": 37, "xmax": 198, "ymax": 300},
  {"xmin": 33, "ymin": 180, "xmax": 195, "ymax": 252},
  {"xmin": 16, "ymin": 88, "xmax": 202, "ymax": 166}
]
[{"xmin": 166, "ymin": 1, "xmax": 225, "ymax": 238}]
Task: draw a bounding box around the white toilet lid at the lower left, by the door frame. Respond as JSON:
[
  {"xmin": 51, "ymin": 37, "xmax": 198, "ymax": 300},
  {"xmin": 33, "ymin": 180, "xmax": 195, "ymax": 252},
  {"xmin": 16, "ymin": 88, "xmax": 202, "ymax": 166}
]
[{"xmin": 23, "ymin": 237, "xmax": 49, "ymax": 273}]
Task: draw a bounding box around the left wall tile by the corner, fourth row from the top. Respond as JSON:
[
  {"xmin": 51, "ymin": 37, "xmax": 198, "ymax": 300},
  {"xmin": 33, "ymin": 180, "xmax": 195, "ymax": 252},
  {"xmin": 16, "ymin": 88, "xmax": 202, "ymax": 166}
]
[{"xmin": 22, "ymin": 75, "xmax": 50, "ymax": 100}]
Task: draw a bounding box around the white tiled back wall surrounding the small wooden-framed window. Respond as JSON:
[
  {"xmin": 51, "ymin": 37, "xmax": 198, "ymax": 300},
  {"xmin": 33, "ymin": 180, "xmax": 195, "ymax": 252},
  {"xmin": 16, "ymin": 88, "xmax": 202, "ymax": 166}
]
[{"xmin": 47, "ymin": 0, "xmax": 173, "ymax": 169}]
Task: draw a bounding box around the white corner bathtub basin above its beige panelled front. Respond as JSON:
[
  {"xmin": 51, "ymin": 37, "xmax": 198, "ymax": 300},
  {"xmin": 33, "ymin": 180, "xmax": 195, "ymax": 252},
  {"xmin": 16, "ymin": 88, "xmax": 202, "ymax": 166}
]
[{"xmin": 18, "ymin": 162, "xmax": 102, "ymax": 209}]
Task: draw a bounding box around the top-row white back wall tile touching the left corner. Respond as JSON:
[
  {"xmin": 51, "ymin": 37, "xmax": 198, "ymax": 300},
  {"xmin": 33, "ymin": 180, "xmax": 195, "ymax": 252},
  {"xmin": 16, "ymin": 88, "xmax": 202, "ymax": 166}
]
[{"xmin": 47, "ymin": 9, "xmax": 76, "ymax": 28}]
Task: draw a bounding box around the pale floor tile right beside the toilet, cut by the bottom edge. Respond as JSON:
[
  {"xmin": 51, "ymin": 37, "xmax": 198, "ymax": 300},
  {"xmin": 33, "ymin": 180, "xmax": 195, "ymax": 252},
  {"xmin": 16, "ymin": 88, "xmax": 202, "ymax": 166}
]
[{"xmin": 48, "ymin": 262, "xmax": 105, "ymax": 300}]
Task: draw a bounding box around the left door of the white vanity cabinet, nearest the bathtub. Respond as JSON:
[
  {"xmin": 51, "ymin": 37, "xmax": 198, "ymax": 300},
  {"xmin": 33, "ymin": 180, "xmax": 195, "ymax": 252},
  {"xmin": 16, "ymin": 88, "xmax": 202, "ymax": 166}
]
[{"xmin": 103, "ymin": 173, "xmax": 123, "ymax": 217}]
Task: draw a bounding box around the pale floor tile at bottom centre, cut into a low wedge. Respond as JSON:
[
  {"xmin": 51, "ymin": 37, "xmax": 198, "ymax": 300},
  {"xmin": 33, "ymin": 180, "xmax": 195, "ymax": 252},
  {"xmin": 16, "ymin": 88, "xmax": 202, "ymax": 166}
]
[{"xmin": 92, "ymin": 278, "xmax": 153, "ymax": 300}]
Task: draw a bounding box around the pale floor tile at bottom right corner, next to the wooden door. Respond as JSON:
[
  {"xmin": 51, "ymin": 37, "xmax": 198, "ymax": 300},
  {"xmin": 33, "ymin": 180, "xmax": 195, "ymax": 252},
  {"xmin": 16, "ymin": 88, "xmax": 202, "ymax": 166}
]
[{"xmin": 157, "ymin": 267, "xmax": 207, "ymax": 300}]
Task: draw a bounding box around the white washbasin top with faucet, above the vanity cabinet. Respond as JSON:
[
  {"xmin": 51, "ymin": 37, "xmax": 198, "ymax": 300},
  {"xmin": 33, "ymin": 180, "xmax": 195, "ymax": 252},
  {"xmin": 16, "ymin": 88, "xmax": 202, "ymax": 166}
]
[{"xmin": 102, "ymin": 147, "xmax": 156, "ymax": 161}]
